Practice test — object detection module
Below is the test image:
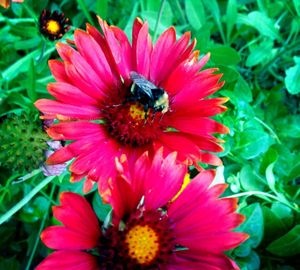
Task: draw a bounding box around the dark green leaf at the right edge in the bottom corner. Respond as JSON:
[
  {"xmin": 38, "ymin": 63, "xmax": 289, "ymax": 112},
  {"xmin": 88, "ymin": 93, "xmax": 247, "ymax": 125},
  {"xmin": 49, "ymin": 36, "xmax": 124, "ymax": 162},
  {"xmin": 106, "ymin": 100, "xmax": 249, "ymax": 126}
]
[{"xmin": 267, "ymin": 225, "xmax": 300, "ymax": 257}]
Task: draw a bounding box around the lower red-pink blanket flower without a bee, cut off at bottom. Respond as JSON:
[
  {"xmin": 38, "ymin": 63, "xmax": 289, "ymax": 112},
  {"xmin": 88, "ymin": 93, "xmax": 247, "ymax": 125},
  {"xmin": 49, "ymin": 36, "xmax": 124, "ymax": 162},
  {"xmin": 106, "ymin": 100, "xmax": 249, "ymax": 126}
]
[{"xmin": 36, "ymin": 151, "xmax": 248, "ymax": 270}]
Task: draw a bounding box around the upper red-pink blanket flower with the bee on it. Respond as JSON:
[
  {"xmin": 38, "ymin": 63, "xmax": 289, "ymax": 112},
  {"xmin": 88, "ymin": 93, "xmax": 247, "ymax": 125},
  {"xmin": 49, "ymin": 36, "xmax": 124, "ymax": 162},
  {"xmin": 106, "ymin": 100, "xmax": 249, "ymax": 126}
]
[{"xmin": 35, "ymin": 18, "xmax": 228, "ymax": 190}]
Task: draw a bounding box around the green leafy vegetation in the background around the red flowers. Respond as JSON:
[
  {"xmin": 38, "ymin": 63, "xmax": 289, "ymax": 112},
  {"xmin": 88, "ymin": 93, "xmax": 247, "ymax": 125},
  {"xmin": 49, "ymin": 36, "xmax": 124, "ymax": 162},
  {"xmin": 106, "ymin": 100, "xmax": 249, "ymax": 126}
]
[{"xmin": 0, "ymin": 0, "xmax": 300, "ymax": 270}]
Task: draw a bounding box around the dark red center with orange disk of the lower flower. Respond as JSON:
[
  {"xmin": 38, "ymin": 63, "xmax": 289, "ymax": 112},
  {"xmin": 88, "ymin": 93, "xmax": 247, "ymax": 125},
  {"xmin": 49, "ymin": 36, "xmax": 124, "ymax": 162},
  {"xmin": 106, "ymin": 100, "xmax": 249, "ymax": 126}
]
[{"xmin": 99, "ymin": 211, "xmax": 175, "ymax": 270}]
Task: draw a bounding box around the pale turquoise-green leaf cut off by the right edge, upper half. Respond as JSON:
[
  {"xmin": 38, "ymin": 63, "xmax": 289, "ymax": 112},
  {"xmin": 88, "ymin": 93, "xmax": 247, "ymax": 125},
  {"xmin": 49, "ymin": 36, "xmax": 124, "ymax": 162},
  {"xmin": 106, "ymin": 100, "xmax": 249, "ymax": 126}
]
[{"xmin": 284, "ymin": 56, "xmax": 300, "ymax": 95}]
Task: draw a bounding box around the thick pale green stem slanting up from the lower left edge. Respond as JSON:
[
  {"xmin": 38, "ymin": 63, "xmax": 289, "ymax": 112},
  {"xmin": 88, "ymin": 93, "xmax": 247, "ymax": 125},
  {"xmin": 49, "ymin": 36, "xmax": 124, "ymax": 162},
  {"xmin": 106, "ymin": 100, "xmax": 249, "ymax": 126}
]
[{"xmin": 0, "ymin": 176, "xmax": 55, "ymax": 225}]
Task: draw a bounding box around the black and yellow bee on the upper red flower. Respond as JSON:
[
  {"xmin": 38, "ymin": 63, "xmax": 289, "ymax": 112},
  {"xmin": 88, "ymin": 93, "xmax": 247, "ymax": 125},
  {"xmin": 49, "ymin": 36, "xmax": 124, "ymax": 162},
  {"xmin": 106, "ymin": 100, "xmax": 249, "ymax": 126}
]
[{"xmin": 128, "ymin": 71, "xmax": 169, "ymax": 114}]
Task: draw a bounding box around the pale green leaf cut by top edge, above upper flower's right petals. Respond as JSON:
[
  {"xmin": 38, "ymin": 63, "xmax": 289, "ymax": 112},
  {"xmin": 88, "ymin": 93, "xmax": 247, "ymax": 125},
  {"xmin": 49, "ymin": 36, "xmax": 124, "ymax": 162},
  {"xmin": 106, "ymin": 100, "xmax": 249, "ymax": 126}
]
[{"xmin": 185, "ymin": 0, "xmax": 206, "ymax": 30}]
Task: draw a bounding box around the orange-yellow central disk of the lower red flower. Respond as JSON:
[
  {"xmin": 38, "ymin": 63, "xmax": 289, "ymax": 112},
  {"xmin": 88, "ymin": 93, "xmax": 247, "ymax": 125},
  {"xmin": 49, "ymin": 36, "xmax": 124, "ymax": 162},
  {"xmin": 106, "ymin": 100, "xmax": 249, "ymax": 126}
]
[{"xmin": 125, "ymin": 225, "xmax": 160, "ymax": 265}]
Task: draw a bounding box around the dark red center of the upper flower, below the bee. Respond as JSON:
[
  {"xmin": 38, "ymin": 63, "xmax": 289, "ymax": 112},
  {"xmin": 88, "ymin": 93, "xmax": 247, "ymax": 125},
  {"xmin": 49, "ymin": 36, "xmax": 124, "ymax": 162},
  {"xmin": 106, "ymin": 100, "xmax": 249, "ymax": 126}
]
[{"xmin": 102, "ymin": 88, "xmax": 166, "ymax": 147}]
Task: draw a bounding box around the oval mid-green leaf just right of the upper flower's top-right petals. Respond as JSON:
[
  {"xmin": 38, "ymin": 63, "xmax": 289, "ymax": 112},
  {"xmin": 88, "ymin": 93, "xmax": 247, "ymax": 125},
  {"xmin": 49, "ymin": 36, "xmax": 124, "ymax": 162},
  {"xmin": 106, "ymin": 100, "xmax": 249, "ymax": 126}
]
[{"xmin": 209, "ymin": 46, "xmax": 241, "ymax": 65}]
